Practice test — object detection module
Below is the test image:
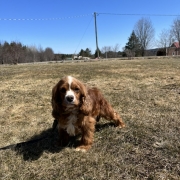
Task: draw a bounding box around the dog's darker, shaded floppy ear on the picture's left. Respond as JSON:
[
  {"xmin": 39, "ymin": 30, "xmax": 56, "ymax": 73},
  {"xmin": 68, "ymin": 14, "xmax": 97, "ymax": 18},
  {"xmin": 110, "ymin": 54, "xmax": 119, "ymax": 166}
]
[{"xmin": 51, "ymin": 83, "xmax": 62, "ymax": 119}]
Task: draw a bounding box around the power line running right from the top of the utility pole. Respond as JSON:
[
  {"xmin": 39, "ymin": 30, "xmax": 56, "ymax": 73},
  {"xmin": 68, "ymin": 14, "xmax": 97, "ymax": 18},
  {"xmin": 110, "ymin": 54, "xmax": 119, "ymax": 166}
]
[{"xmin": 97, "ymin": 13, "xmax": 180, "ymax": 16}]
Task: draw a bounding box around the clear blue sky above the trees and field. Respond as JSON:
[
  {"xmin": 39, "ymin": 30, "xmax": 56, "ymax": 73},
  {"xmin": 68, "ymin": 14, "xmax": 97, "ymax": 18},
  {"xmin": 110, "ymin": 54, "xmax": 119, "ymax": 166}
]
[{"xmin": 0, "ymin": 0, "xmax": 180, "ymax": 54}]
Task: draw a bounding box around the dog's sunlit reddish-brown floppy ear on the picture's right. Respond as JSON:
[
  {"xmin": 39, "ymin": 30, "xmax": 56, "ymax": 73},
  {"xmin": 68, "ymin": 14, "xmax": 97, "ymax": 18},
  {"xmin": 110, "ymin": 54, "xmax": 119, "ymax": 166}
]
[{"xmin": 80, "ymin": 85, "xmax": 92, "ymax": 115}]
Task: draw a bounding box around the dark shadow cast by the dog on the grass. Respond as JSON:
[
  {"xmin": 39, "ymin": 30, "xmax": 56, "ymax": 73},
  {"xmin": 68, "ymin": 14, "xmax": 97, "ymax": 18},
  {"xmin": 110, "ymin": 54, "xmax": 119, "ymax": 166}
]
[{"xmin": 13, "ymin": 121, "xmax": 114, "ymax": 161}]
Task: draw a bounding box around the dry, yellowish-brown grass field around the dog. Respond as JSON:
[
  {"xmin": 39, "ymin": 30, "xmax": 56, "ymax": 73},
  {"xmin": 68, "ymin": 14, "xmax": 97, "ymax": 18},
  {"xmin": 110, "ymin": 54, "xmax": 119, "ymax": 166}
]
[{"xmin": 0, "ymin": 59, "xmax": 180, "ymax": 180}]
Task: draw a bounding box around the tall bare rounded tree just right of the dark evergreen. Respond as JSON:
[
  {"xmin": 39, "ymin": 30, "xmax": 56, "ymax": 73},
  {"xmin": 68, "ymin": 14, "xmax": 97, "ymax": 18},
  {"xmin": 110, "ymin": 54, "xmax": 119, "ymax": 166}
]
[{"xmin": 134, "ymin": 18, "xmax": 155, "ymax": 56}]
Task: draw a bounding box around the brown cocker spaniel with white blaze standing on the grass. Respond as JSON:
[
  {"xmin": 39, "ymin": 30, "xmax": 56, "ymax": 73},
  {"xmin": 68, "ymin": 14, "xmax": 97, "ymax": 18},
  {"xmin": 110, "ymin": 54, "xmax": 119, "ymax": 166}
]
[{"xmin": 52, "ymin": 76, "xmax": 125, "ymax": 152}]
